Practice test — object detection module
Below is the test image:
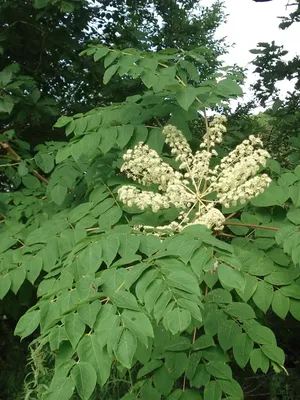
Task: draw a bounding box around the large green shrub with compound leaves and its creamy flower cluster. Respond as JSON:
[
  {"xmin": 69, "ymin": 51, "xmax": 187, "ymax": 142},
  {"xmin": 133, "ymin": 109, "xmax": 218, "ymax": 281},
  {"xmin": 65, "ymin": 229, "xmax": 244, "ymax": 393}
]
[{"xmin": 0, "ymin": 46, "xmax": 300, "ymax": 400}]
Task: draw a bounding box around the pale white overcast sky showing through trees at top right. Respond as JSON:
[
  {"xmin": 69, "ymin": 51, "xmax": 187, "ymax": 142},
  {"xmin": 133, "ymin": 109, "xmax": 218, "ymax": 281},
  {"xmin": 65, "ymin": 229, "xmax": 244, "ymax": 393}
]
[{"xmin": 201, "ymin": 0, "xmax": 300, "ymax": 108}]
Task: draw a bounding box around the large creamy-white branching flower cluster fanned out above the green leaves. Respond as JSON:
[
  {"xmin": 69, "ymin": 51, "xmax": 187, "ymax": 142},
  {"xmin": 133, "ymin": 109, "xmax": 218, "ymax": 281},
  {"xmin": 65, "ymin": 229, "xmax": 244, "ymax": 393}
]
[{"xmin": 118, "ymin": 116, "xmax": 271, "ymax": 231}]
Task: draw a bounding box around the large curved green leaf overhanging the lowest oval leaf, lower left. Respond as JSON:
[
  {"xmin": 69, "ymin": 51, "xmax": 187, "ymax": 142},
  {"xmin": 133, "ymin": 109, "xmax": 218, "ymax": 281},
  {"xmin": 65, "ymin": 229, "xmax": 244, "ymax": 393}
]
[{"xmin": 77, "ymin": 334, "xmax": 112, "ymax": 386}]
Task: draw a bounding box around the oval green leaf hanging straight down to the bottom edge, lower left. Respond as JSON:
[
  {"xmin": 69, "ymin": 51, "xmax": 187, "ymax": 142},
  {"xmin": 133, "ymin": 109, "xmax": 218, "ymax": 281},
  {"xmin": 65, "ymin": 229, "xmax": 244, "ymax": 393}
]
[{"xmin": 71, "ymin": 362, "xmax": 97, "ymax": 400}]
